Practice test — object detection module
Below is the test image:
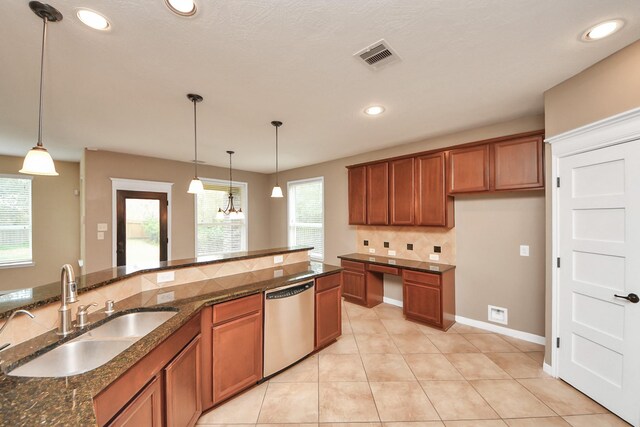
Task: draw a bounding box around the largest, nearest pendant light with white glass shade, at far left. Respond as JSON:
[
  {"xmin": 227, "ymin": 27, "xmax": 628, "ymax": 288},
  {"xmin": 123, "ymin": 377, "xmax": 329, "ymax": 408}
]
[{"xmin": 20, "ymin": 1, "xmax": 62, "ymax": 176}]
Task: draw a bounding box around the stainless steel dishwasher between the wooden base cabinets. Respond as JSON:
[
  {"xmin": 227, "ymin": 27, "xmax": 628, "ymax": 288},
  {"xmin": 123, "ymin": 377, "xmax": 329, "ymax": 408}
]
[{"xmin": 264, "ymin": 282, "xmax": 315, "ymax": 378}]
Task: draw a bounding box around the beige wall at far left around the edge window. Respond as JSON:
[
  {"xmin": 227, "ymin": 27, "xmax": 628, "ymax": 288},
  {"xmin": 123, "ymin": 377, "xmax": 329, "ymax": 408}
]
[{"xmin": 0, "ymin": 156, "xmax": 80, "ymax": 290}]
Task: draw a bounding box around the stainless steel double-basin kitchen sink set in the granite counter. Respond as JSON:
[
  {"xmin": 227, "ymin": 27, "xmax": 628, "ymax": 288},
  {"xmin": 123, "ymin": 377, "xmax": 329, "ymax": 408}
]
[{"xmin": 7, "ymin": 311, "xmax": 176, "ymax": 377}]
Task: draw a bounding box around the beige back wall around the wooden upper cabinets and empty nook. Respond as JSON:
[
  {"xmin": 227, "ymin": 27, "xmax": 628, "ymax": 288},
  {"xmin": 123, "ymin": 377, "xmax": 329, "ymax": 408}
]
[{"xmin": 271, "ymin": 116, "xmax": 545, "ymax": 334}]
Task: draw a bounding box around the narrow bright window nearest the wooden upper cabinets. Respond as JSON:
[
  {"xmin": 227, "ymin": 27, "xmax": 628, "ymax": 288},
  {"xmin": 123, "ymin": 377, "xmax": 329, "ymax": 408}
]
[{"xmin": 288, "ymin": 178, "xmax": 324, "ymax": 261}]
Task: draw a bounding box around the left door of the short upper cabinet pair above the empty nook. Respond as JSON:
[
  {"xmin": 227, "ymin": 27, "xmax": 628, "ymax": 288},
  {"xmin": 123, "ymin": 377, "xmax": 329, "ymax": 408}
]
[{"xmin": 449, "ymin": 144, "xmax": 489, "ymax": 194}]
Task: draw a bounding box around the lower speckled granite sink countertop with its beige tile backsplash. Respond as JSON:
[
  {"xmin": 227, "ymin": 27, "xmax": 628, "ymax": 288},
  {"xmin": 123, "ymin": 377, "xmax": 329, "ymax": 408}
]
[{"xmin": 0, "ymin": 261, "xmax": 342, "ymax": 426}]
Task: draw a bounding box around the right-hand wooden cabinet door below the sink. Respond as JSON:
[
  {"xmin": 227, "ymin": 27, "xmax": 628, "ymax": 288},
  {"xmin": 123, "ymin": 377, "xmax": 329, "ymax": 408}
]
[{"xmin": 164, "ymin": 335, "xmax": 202, "ymax": 427}]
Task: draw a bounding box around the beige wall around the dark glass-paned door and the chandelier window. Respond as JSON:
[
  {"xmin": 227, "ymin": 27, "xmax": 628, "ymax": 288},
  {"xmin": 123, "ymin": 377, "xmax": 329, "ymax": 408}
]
[{"xmin": 83, "ymin": 150, "xmax": 272, "ymax": 273}]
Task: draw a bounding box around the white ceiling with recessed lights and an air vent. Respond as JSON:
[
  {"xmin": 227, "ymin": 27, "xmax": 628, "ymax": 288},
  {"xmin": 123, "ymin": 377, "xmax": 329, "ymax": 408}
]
[{"xmin": 0, "ymin": 0, "xmax": 640, "ymax": 172}]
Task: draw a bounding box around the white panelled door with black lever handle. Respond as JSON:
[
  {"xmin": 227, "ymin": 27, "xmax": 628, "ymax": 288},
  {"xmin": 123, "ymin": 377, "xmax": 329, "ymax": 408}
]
[{"xmin": 558, "ymin": 141, "xmax": 640, "ymax": 426}]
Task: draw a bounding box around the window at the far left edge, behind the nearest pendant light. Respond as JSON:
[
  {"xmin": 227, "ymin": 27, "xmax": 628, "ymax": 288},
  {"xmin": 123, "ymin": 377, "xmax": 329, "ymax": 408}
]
[{"xmin": 0, "ymin": 175, "xmax": 32, "ymax": 267}]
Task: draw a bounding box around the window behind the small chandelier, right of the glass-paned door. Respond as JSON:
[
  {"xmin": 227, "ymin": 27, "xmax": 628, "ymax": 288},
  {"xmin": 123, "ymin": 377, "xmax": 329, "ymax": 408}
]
[{"xmin": 196, "ymin": 179, "xmax": 247, "ymax": 257}]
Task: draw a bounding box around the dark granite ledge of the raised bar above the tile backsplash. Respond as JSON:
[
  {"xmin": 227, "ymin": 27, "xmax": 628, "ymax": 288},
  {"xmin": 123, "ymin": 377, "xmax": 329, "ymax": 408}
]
[{"xmin": 0, "ymin": 246, "xmax": 313, "ymax": 320}]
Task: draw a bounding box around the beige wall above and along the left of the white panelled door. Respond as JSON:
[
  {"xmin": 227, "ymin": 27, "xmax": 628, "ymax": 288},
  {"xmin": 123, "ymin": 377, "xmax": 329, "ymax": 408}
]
[{"xmin": 544, "ymin": 41, "xmax": 640, "ymax": 364}]
